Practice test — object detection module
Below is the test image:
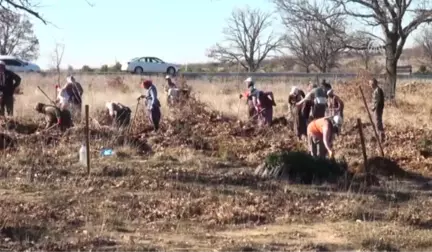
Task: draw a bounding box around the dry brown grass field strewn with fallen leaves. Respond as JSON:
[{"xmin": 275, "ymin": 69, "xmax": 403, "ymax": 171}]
[{"xmin": 0, "ymin": 72, "xmax": 432, "ymax": 251}]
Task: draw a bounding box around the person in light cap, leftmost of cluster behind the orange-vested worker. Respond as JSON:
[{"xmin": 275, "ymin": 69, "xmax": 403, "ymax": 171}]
[{"xmin": 288, "ymin": 86, "xmax": 310, "ymax": 139}]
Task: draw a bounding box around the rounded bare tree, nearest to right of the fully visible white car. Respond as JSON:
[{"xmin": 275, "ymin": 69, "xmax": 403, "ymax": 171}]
[{"xmin": 208, "ymin": 7, "xmax": 283, "ymax": 72}]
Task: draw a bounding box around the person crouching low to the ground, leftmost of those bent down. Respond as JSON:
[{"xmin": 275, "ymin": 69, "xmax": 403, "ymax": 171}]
[{"xmin": 35, "ymin": 103, "xmax": 73, "ymax": 131}]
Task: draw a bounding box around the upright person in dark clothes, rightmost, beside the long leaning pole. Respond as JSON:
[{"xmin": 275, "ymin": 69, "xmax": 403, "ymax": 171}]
[{"xmin": 369, "ymin": 78, "xmax": 385, "ymax": 142}]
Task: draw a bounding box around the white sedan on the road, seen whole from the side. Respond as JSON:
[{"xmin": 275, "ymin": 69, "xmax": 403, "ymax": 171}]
[{"xmin": 122, "ymin": 57, "xmax": 180, "ymax": 75}]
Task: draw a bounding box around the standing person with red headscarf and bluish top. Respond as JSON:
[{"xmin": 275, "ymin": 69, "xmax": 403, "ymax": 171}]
[{"xmin": 138, "ymin": 80, "xmax": 161, "ymax": 131}]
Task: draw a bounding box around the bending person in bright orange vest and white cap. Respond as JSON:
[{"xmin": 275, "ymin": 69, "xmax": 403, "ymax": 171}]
[{"xmin": 307, "ymin": 115, "xmax": 343, "ymax": 158}]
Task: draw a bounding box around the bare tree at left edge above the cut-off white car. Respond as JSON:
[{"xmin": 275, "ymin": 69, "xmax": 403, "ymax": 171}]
[{"xmin": 0, "ymin": 10, "xmax": 39, "ymax": 60}]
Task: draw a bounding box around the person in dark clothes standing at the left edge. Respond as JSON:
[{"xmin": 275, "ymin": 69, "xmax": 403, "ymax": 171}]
[{"xmin": 0, "ymin": 61, "xmax": 21, "ymax": 116}]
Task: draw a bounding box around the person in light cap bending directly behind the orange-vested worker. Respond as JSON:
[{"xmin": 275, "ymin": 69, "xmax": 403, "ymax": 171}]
[{"xmin": 297, "ymin": 81, "xmax": 327, "ymax": 119}]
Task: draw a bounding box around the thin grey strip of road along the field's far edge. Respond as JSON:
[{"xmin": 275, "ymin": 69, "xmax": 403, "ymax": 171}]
[{"xmin": 33, "ymin": 71, "xmax": 432, "ymax": 79}]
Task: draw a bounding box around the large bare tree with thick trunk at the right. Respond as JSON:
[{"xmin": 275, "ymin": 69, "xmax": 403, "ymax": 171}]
[{"xmin": 279, "ymin": 0, "xmax": 432, "ymax": 98}]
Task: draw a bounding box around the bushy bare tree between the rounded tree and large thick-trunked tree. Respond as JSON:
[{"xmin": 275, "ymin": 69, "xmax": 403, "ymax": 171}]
[{"xmin": 274, "ymin": 0, "xmax": 349, "ymax": 72}]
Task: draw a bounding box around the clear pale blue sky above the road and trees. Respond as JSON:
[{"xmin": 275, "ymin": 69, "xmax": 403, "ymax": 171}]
[{"xmin": 32, "ymin": 0, "xmax": 422, "ymax": 69}]
